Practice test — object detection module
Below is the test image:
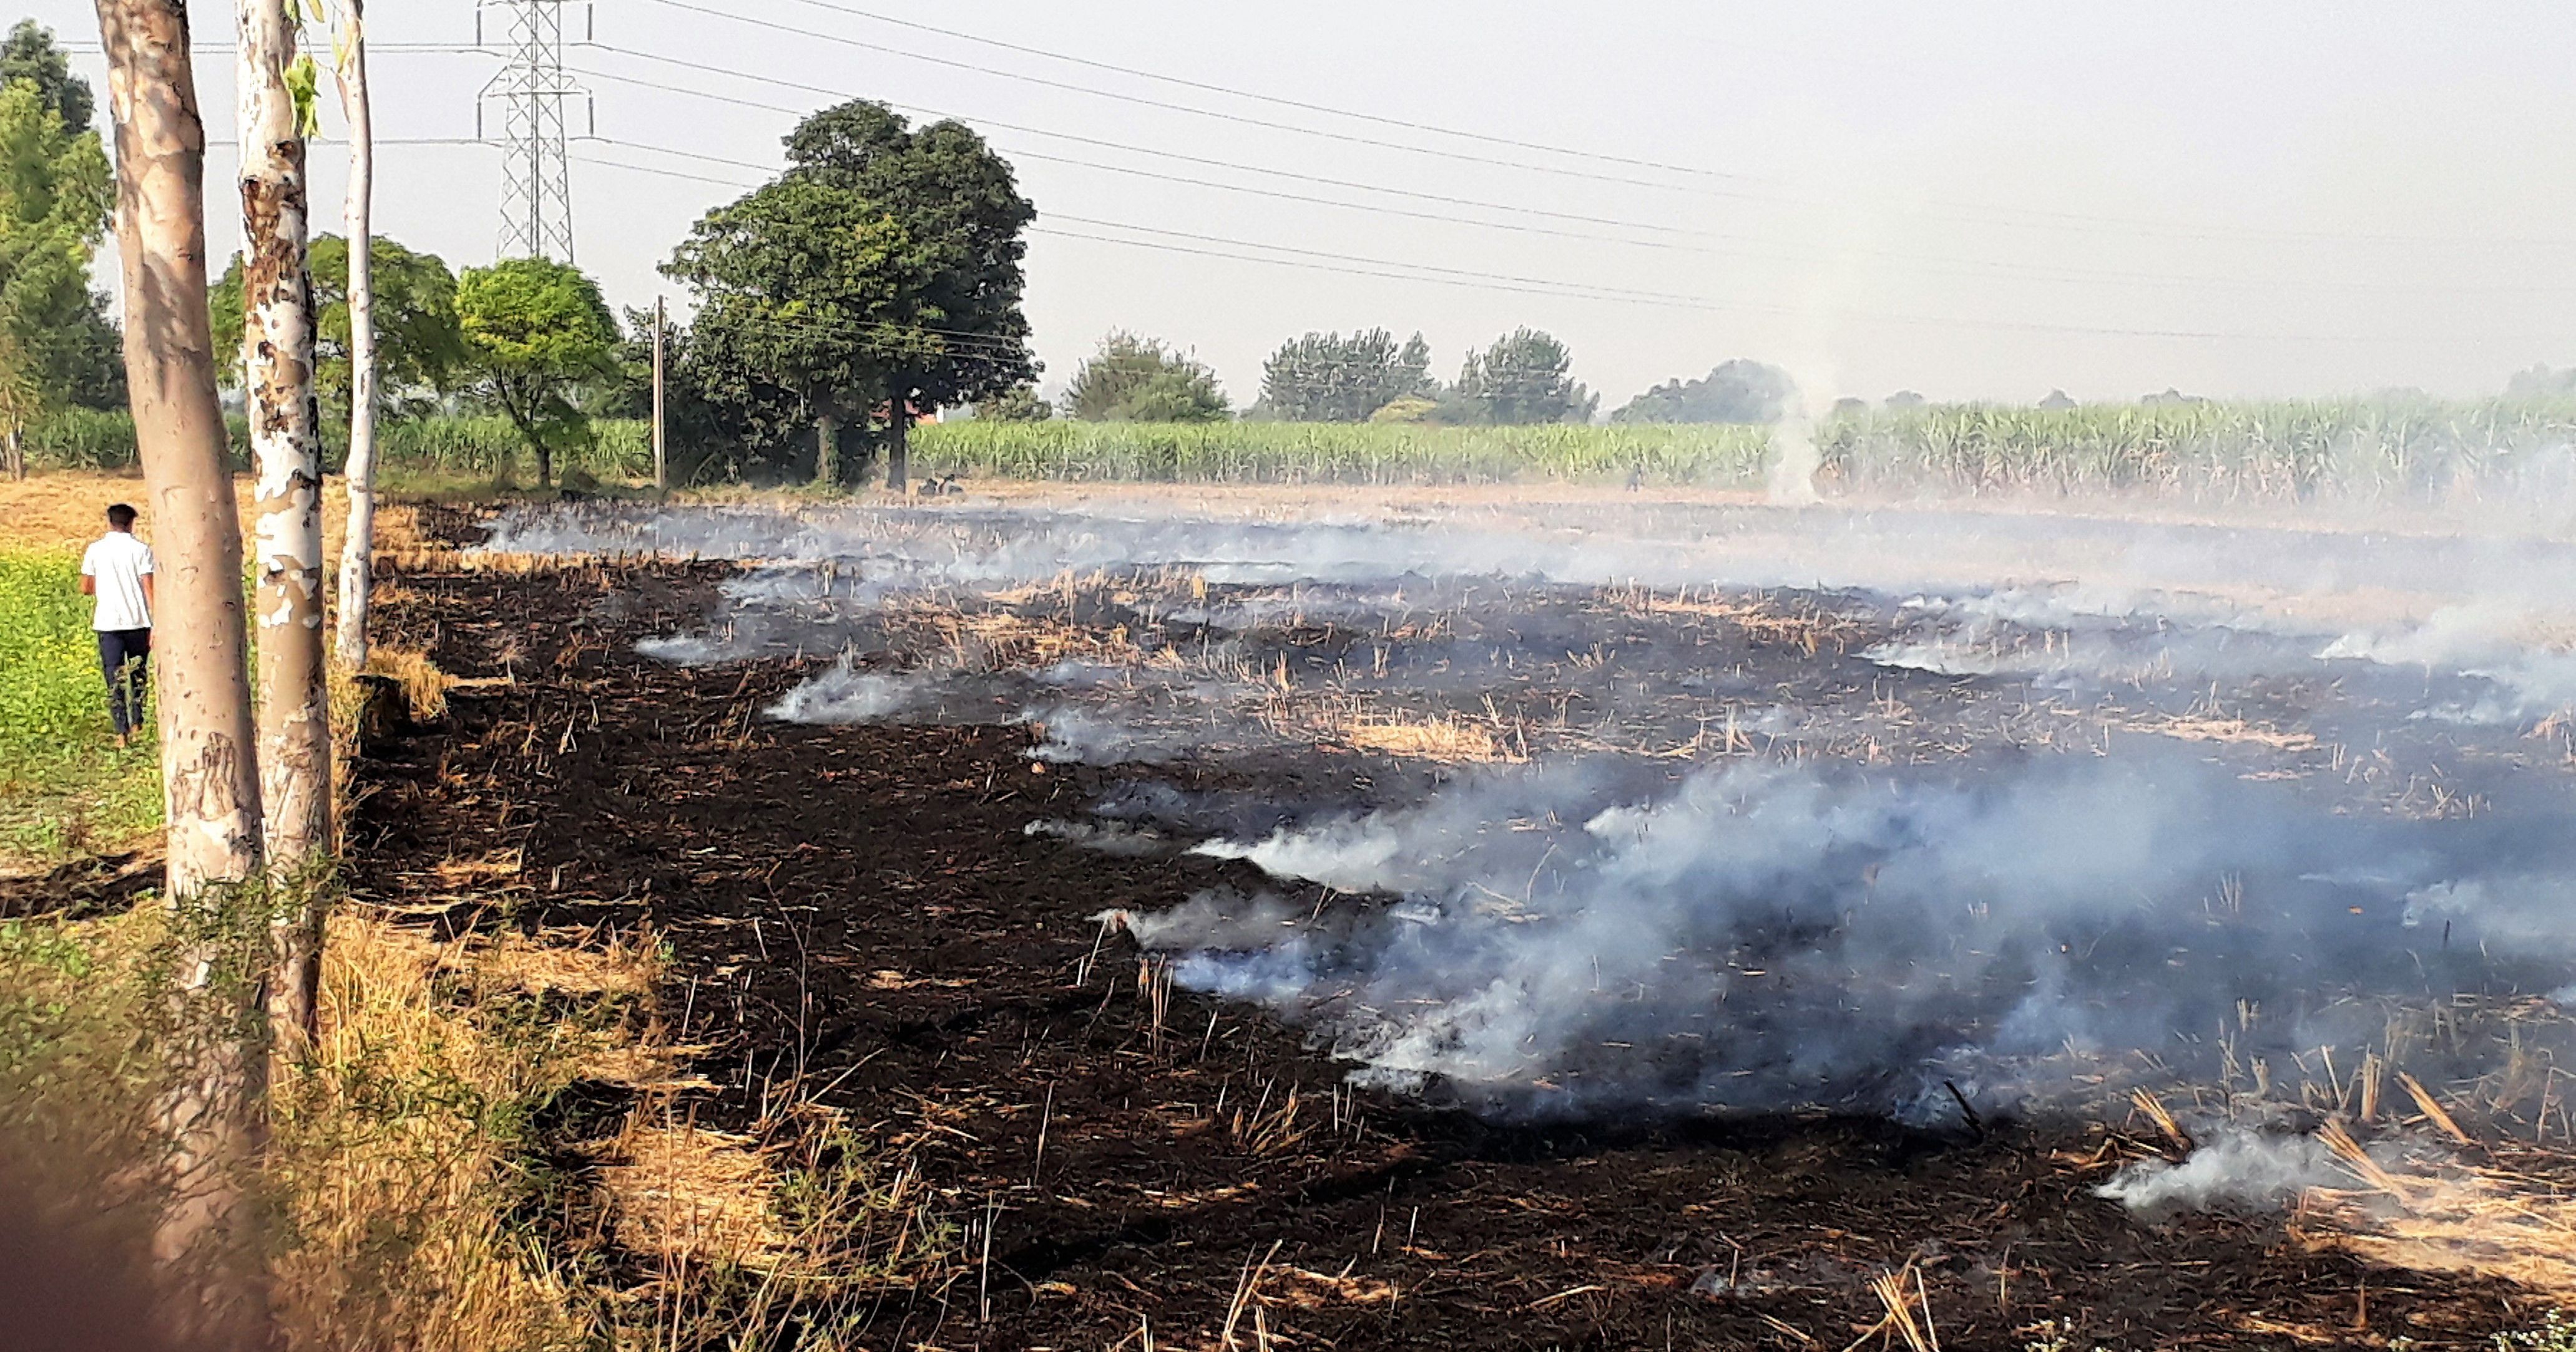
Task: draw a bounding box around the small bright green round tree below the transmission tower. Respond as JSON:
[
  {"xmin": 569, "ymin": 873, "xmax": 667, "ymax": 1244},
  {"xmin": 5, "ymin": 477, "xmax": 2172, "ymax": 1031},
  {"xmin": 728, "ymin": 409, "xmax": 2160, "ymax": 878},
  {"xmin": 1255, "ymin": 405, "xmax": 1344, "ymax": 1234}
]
[{"xmin": 456, "ymin": 258, "xmax": 618, "ymax": 484}]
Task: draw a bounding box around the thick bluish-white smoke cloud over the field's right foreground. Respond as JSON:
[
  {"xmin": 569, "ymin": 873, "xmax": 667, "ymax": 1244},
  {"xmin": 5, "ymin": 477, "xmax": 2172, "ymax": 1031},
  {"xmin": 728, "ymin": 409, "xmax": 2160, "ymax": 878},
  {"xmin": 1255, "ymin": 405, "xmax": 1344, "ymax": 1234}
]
[{"xmin": 1112, "ymin": 752, "xmax": 2576, "ymax": 1115}]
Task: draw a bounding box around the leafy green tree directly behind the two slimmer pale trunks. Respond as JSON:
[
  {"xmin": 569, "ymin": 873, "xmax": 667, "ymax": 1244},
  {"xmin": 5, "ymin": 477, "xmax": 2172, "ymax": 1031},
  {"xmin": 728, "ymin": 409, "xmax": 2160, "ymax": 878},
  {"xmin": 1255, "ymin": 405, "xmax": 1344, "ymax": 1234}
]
[{"xmin": 206, "ymin": 234, "xmax": 466, "ymax": 423}]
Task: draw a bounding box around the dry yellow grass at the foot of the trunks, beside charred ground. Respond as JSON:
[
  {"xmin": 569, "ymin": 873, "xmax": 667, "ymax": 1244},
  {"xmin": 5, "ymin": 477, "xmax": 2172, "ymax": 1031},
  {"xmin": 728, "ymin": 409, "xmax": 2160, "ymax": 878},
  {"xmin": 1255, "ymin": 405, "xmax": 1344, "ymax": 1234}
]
[{"xmin": 273, "ymin": 901, "xmax": 956, "ymax": 1352}]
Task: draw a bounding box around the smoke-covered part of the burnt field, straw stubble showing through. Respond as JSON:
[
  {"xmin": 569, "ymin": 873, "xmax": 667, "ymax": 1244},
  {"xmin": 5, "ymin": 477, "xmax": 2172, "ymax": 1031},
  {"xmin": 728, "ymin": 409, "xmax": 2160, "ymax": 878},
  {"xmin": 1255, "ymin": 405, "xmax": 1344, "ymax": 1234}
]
[{"xmin": 494, "ymin": 492, "xmax": 2576, "ymax": 1120}]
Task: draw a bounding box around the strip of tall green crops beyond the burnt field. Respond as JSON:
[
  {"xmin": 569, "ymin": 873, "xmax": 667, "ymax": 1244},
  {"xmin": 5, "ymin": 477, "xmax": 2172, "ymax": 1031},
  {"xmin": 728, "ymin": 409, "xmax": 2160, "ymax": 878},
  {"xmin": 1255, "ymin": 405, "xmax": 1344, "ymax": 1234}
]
[{"xmin": 28, "ymin": 396, "xmax": 2576, "ymax": 499}]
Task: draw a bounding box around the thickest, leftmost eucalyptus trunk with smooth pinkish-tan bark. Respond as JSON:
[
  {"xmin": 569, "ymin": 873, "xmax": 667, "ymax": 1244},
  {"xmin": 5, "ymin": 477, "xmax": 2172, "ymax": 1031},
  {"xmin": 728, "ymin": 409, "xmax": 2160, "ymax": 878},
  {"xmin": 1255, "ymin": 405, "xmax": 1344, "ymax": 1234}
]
[{"xmin": 98, "ymin": 0, "xmax": 265, "ymax": 1345}]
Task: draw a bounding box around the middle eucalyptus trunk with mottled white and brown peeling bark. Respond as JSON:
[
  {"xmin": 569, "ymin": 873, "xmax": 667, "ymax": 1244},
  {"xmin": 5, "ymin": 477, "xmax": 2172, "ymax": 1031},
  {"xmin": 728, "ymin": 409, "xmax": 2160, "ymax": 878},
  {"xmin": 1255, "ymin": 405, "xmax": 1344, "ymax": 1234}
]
[{"xmin": 235, "ymin": 0, "xmax": 330, "ymax": 1053}]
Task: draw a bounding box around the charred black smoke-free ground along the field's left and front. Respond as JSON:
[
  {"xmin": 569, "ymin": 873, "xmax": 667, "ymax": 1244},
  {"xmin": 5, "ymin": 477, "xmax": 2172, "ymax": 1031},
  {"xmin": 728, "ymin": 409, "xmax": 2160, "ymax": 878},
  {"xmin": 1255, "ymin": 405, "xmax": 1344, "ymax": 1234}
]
[{"xmin": 332, "ymin": 515, "xmax": 2537, "ymax": 1352}]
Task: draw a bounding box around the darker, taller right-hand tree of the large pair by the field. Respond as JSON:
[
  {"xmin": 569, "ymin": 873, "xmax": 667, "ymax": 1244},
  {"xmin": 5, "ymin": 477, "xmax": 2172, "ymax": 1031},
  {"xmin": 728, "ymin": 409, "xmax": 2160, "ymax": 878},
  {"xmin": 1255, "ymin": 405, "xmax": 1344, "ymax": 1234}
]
[{"xmin": 786, "ymin": 100, "xmax": 1038, "ymax": 492}]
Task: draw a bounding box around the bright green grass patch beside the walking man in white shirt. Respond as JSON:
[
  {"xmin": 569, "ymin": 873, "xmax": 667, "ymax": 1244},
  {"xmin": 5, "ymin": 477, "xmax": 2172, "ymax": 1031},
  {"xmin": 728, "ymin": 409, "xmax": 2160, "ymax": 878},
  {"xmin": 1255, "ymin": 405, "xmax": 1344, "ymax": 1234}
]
[{"xmin": 0, "ymin": 549, "xmax": 160, "ymax": 863}]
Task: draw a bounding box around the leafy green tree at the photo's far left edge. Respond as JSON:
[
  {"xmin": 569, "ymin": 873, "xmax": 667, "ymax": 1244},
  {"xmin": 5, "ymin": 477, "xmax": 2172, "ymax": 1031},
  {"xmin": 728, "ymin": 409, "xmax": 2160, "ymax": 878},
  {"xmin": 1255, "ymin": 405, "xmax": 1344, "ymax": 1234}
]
[{"xmin": 0, "ymin": 80, "xmax": 121, "ymax": 471}]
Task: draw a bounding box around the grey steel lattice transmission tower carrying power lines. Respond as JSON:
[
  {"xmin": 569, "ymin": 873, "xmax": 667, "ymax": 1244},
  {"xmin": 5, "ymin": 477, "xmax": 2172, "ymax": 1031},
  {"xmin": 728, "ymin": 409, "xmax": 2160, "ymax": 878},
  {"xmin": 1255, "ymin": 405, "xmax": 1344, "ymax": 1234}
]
[{"xmin": 474, "ymin": 0, "xmax": 597, "ymax": 263}]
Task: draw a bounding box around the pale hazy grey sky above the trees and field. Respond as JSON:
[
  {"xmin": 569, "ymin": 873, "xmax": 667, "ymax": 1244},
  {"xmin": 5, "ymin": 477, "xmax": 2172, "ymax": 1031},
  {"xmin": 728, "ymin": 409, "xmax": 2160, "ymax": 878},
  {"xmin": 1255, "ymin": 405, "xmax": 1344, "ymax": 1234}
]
[{"xmin": 34, "ymin": 0, "xmax": 2576, "ymax": 409}]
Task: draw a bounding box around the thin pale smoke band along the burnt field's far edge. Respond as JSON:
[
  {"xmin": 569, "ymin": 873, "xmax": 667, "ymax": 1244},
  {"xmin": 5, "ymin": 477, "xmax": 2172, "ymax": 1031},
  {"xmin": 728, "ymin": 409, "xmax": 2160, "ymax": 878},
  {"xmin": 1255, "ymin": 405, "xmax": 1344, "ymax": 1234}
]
[{"xmin": 487, "ymin": 499, "xmax": 2576, "ymax": 652}]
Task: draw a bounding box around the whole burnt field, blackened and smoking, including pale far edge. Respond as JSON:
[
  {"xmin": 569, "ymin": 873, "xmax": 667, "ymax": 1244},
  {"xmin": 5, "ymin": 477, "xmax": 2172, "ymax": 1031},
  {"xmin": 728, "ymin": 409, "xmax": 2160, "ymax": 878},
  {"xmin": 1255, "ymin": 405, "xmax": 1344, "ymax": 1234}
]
[{"xmin": 356, "ymin": 494, "xmax": 2576, "ymax": 1352}]
